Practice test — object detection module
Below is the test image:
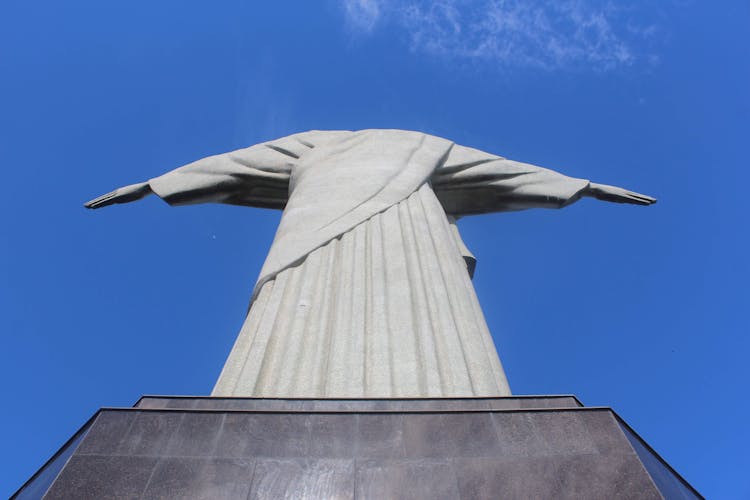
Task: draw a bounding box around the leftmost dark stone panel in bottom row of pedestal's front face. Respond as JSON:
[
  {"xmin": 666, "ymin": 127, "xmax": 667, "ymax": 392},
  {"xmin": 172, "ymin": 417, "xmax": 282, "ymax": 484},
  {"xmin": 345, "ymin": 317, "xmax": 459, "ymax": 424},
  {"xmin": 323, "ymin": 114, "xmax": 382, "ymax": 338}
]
[{"xmin": 44, "ymin": 455, "xmax": 157, "ymax": 500}]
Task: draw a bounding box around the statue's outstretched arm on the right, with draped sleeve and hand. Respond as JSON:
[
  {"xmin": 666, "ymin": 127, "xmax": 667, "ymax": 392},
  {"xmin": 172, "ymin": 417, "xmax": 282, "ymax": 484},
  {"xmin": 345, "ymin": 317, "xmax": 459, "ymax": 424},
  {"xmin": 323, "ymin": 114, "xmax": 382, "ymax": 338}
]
[{"xmin": 431, "ymin": 145, "xmax": 656, "ymax": 216}]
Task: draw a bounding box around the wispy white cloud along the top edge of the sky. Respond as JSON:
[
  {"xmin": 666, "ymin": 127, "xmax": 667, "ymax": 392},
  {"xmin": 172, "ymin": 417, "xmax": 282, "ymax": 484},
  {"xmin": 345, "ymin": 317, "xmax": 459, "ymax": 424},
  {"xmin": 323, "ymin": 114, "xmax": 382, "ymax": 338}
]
[{"xmin": 342, "ymin": 0, "xmax": 656, "ymax": 70}]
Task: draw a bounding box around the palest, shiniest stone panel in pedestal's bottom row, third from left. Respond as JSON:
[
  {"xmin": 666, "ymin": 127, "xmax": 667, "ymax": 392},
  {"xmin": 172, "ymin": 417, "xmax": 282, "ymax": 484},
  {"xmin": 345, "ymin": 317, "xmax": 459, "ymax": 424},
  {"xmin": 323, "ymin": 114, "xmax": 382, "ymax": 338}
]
[{"xmin": 248, "ymin": 459, "xmax": 354, "ymax": 500}]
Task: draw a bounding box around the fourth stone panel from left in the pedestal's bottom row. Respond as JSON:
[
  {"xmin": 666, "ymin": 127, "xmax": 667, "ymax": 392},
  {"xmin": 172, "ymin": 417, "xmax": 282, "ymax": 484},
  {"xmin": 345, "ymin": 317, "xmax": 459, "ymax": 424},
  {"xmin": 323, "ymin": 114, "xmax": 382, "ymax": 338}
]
[{"xmin": 356, "ymin": 460, "xmax": 459, "ymax": 500}]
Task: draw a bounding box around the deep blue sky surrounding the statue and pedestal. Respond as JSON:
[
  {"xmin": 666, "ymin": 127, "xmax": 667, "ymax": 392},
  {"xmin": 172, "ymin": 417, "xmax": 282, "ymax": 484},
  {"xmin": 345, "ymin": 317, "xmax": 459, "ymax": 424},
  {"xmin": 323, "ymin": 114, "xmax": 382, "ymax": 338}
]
[{"xmin": 0, "ymin": 0, "xmax": 750, "ymax": 498}]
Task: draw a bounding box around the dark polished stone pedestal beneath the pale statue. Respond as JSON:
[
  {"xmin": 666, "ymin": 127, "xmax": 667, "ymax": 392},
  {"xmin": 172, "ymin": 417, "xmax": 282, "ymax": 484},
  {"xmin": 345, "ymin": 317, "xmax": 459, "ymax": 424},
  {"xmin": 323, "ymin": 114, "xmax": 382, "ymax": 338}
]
[{"xmin": 16, "ymin": 396, "xmax": 701, "ymax": 500}]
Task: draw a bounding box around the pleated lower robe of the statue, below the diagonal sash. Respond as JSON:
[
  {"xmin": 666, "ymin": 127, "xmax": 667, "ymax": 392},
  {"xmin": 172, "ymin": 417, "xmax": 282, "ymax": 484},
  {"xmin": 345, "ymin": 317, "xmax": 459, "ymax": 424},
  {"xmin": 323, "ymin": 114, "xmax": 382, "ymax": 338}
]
[{"xmin": 212, "ymin": 183, "xmax": 510, "ymax": 398}]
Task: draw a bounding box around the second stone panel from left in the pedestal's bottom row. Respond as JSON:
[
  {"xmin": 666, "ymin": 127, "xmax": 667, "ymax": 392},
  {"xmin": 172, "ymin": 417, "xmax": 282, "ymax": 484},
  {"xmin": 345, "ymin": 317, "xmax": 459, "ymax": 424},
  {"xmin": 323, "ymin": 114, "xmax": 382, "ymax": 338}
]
[{"xmin": 142, "ymin": 457, "xmax": 255, "ymax": 500}]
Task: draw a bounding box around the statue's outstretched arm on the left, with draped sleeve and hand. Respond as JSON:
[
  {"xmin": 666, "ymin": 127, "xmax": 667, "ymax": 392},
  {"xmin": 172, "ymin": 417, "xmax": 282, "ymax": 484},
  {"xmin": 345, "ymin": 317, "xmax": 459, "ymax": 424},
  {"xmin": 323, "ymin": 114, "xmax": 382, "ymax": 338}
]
[{"xmin": 85, "ymin": 134, "xmax": 312, "ymax": 208}]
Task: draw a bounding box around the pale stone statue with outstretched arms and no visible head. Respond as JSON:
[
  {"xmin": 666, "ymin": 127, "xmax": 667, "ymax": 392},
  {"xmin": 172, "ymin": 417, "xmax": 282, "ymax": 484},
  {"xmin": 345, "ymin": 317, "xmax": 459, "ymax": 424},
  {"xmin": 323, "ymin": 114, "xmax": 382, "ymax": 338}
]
[{"xmin": 86, "ymin": 130, "xmax": 655, "ymax": 398}]
